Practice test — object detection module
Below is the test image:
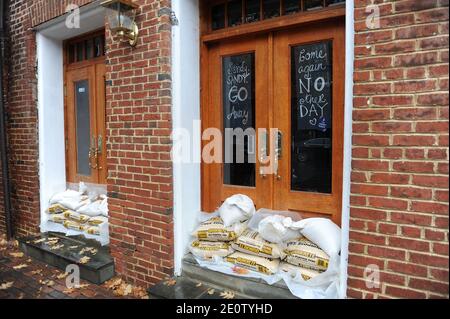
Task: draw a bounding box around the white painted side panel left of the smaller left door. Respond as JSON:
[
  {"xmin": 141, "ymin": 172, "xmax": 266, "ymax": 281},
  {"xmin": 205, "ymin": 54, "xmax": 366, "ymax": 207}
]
[{"xmin": 36, "ymin": 32, "xmax": 66, "ymax": 232}]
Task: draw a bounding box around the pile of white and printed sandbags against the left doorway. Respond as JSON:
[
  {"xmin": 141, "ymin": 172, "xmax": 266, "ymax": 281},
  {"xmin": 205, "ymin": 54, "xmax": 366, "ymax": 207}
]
[{"xmin": 46, "ymin": 183, "xmax": 109, "ymax": 241}]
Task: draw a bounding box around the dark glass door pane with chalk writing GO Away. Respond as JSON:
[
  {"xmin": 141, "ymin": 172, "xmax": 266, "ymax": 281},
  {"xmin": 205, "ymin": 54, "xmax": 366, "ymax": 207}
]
[{"xmin": 222, "ymin": 53, "xmax": 256, "ymax": 186}]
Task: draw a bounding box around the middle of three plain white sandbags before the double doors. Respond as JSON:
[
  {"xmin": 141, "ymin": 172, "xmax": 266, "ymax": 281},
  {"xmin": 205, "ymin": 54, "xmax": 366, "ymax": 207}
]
[{"xmin": 258, "ymin": 215, "xmax": 300, "ymax": 244}]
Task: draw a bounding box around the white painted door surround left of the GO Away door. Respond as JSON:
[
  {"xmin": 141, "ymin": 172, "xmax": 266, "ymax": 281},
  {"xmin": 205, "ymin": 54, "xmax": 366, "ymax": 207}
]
[{"xmin": 172, "ymin": 0, "xmax": 201, "ymax": 275}]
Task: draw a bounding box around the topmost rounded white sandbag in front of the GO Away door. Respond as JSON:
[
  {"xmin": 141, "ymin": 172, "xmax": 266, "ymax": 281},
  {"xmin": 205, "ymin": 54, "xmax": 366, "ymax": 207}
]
[{"xmin": 219, "ymin": 194, "xmax": 255, "ymax": 227}]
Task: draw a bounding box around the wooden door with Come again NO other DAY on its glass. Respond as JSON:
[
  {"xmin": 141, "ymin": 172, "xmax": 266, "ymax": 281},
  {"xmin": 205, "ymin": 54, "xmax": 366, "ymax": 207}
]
[{"xmin": 273, "ymin": 21, "xmax": 345, "ymax": 224}]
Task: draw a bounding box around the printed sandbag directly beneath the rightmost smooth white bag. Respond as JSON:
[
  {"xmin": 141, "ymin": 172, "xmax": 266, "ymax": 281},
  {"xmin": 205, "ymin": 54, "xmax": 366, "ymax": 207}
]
[{"xmin": 284, "ymin": 237, "xmax": 330, "ymax": 272}]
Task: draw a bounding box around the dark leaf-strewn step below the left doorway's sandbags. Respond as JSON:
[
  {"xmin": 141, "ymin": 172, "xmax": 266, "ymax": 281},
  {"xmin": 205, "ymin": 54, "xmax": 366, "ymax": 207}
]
[{"xmin": 18, "ymin": 233, "xmax": 114, "ymax": 285}]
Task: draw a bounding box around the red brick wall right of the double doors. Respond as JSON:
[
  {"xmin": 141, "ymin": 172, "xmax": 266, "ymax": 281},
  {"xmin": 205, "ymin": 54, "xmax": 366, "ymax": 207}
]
[{"xmin": 348, "ymin": 0, "xmax": 449, "ymax": 298}]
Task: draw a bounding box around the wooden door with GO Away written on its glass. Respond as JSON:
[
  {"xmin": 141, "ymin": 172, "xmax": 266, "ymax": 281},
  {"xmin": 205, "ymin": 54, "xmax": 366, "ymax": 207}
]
[{"xmin": 202, "ymin": 36, "xmax": 272, "ymax": 211}]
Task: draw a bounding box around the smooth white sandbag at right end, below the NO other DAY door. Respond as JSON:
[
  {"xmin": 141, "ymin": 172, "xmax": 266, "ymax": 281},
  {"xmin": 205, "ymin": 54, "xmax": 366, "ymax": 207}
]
[{"xmin": 295, "ymin": 218, "xmax": 341, "ymax": 256}]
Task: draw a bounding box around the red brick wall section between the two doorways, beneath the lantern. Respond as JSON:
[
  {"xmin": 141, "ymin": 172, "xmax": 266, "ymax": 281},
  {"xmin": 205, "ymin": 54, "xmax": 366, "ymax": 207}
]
[{"xmin": 106, "ymin": 0, "xmax": 173, "ymax": 285}]
